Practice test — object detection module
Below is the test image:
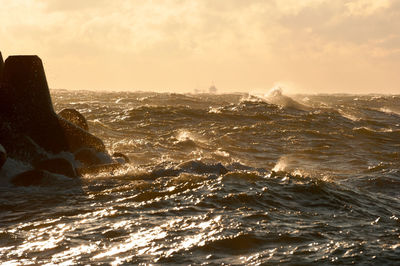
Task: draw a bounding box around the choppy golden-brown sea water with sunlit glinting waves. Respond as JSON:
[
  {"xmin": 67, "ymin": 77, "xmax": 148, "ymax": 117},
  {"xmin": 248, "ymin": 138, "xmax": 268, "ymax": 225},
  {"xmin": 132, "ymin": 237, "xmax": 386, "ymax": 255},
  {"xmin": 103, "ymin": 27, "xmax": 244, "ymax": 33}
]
[{"xmin": 0, "ymin": 90, "xmax": 400, "ymax": 265}]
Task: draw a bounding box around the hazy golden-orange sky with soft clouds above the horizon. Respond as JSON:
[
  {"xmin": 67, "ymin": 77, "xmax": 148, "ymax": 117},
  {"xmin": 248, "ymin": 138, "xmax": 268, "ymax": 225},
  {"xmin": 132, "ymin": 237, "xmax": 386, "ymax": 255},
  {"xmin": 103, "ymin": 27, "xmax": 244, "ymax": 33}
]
[{"xmin": 0, "ymin": 0, "xmax": 400, "ymax": 94}]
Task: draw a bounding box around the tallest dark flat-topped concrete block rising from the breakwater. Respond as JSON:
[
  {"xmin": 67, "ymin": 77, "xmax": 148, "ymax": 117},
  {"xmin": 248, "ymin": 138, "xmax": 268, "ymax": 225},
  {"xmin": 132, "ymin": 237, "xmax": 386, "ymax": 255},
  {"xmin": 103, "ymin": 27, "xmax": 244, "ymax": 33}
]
[{"xmin": 0, "ymin": 56, "xmax": 69, "ymax": 153}]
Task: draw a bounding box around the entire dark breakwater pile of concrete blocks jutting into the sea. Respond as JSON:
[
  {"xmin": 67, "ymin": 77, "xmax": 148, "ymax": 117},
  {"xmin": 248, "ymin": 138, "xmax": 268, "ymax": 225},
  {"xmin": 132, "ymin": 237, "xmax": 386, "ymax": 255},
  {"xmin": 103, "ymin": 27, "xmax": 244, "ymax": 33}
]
[{"xmin": 0, "ymin": 53, "xmax": 127, "ymax": 185}]
